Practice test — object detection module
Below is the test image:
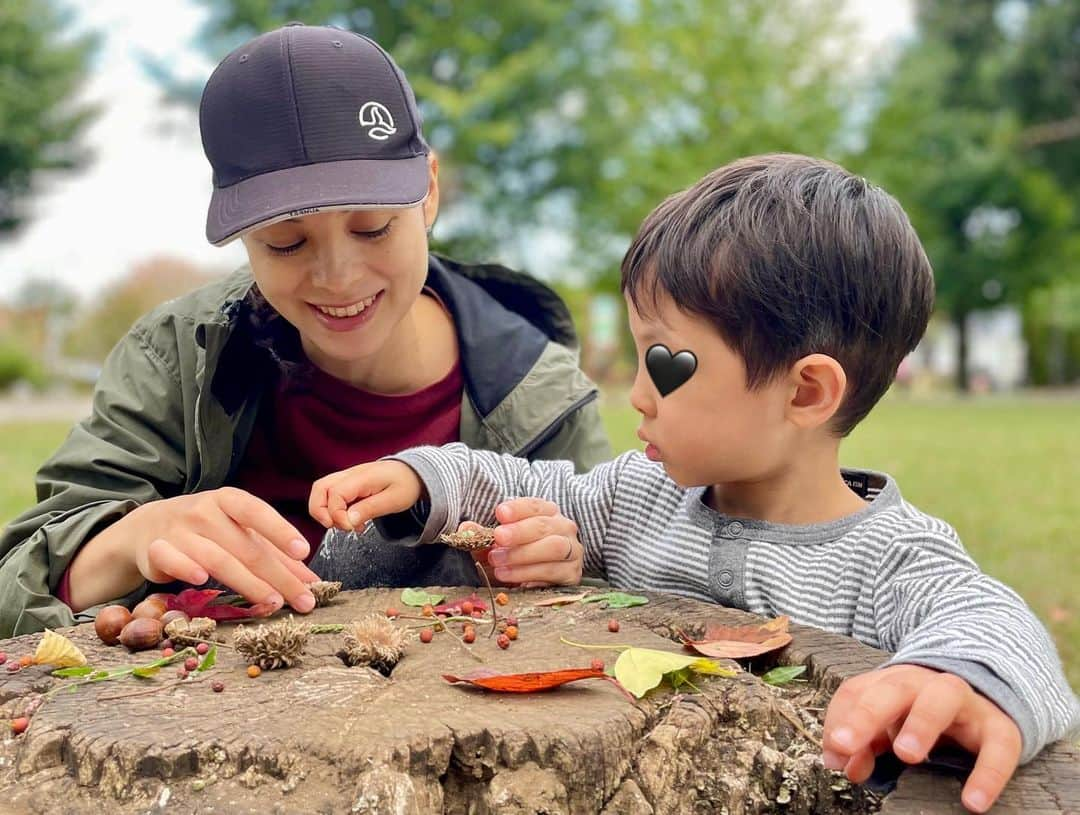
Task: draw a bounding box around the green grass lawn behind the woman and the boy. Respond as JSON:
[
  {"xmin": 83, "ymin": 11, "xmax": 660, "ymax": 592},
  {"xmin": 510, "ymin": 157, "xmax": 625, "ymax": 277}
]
[{"xmin": 0, "ymin": 394, "xmax": 1080, "ymax": 688}]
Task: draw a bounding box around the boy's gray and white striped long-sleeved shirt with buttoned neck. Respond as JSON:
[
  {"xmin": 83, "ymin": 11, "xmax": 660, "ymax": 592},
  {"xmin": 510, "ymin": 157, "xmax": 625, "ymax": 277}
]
[{"xmin": 393, "ymin": 444, "xmax": 1080, "ymax": 761}]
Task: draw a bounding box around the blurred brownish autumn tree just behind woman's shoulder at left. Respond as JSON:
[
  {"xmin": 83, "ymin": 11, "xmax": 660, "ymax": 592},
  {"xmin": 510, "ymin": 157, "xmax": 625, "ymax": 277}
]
[{"xmin": 64, "ymin": 257, "xmax": 212, "ymax": 362}]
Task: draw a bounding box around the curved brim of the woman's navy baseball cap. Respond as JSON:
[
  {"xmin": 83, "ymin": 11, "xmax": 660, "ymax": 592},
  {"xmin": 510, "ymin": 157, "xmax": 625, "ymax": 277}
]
[{"xmin": 206, "ymin": 155, "xmax": 428, "ymax": 246}]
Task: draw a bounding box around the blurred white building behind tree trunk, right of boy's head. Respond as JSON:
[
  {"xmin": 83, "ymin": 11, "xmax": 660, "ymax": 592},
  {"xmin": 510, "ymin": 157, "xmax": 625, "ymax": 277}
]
[{"xmin": 910, "ymin": 305, "xmax": 1027, "ymax": 391}]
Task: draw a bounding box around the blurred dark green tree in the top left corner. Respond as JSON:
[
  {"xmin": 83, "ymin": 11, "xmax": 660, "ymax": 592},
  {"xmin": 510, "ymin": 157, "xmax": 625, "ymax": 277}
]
[{"xmin": 0, "ymin": 0, "xmax": 95, "ymax": 236}]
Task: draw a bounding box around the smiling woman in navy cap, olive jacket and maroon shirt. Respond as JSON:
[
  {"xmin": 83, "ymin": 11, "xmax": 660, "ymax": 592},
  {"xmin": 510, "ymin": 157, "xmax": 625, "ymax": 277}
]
[{"xmin": 0, "ymin": 24, "xmax": 609, "ymax": 637}]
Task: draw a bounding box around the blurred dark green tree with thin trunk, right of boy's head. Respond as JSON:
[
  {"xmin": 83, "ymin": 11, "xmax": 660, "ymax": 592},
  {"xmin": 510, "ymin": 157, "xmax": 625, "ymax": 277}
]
[{"xmin": 859, "ymin": 0, "xmax": 1075, "ymax": 389}]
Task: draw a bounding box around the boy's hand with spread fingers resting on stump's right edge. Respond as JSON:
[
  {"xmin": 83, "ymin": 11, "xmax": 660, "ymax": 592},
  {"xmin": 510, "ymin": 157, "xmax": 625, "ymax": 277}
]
[{"xmin": 822, "ymin": 665, "xmax": 1022, "ymax": 812}]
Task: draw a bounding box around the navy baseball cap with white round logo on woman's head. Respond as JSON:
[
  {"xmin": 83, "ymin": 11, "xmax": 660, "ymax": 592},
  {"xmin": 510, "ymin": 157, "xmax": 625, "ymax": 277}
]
[{"xmin": 199, "ymin": 23, "xmax": 429, "ymax": 246}]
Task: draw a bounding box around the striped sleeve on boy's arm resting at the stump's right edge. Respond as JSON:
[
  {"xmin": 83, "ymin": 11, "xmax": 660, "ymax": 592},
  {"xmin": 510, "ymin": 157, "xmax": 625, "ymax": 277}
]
[{"xmin": 874, "ymin": 524, "xmax": 1080, "ymax": 762}]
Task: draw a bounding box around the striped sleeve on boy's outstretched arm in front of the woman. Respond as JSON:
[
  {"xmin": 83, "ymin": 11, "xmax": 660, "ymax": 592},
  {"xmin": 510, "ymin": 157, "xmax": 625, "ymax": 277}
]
[{"xmin": 392, "ymin": 443, "xmax": 633, "ymax": 574}]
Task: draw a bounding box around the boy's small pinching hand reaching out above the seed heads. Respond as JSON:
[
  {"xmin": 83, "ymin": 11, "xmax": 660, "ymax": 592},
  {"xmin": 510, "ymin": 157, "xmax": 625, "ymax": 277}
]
[{"xmin": 308, "ymin": 461, "xmax": 423, "ymax": 530}]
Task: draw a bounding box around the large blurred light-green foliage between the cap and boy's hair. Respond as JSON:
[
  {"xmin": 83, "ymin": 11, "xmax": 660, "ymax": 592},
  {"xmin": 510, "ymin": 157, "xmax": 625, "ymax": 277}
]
[{"xmin": 170, "ymin": 0, "xmax": 849, "ymax": 286}]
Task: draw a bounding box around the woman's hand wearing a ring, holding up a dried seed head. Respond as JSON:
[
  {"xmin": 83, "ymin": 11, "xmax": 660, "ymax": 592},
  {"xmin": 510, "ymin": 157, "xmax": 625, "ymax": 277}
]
[{"xmin": 459, "ymin": 498, "xmax": 584, "ymax": 587}]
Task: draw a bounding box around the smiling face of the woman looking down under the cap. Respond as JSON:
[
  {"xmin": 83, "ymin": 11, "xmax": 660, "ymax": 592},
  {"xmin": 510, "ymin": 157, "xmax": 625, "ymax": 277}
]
[{"xmin": 242, "ymin": 159, "xmax": 438, "ymax": 378}]
